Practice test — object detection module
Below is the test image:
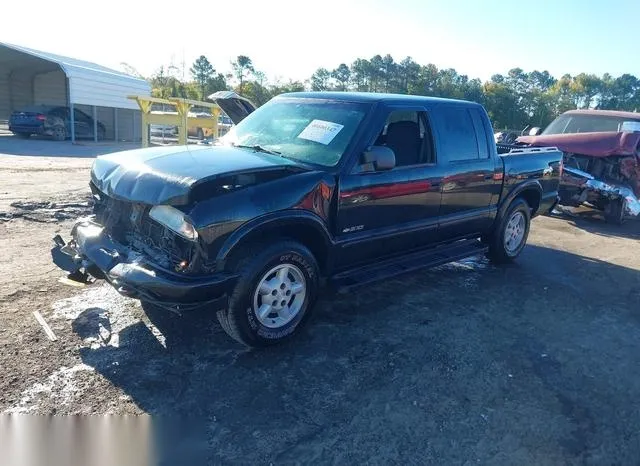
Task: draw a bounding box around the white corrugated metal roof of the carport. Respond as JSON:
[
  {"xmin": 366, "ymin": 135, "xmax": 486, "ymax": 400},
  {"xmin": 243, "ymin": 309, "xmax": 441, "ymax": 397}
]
[{"xmin": 0, "ymin": 42, "xmax": 151, "ymax": 109}]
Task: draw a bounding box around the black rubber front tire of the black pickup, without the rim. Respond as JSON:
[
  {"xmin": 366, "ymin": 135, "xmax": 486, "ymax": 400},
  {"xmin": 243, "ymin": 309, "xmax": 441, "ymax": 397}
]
[{"xmin": 217, "ymin": 240, "xmax": 320, "ymax": 347}]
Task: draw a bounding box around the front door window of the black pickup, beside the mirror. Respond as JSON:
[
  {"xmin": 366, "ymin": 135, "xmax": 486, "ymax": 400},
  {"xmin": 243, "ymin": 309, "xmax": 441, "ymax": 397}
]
[{"xmin": 374, "ymin": 110, "xmax": 435, "ymax": 167}]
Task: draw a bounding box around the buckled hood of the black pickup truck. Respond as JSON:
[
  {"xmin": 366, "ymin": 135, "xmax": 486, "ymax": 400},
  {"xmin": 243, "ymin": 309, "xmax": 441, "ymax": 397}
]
[{"xmin": 91, "ymin": 146, "xmax": 304, "ymax": 205}]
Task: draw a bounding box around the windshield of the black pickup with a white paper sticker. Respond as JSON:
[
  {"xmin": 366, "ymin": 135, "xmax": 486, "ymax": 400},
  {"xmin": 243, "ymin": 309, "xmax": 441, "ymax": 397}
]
[{"xmin": 220, "ymin": 98, "xmax": 368, "ymax": 167}]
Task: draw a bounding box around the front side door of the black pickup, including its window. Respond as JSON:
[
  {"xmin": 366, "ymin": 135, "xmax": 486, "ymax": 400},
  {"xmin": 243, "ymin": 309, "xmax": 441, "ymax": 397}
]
[{"xmin": 336, "ymin": 107, "xmax": 442, "ymax": 268}]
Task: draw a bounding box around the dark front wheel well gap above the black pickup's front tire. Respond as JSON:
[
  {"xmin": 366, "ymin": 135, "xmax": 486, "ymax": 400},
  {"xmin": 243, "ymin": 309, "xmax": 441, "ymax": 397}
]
[{"xmin": 229, "ymin": 224, "xmax": 329, "ymax": 272}]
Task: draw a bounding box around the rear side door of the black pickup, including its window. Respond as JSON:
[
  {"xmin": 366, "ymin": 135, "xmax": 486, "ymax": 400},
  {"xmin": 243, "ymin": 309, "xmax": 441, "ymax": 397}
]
[{"xmin": 433, "ymin": 104, "xmax": 502, "ymax": 240}]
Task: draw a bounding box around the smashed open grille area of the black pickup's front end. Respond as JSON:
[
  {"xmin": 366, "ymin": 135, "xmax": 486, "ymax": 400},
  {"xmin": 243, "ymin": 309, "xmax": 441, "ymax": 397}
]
[{"xmin": 91, "ymin": 185, "xmax": 195, "ymax": 271}]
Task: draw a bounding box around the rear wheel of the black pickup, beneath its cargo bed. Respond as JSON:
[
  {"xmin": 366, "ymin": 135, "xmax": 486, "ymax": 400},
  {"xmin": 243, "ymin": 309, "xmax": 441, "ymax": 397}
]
[{"xmin": 488, "ymin": 198, "xmax": 531, "ymax": 263}]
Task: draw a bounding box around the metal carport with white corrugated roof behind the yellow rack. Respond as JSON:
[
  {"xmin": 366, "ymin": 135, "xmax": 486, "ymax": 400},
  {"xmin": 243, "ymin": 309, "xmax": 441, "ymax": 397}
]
[{"xmin": 0, "ymin": 42, "xmax": 151, "ymax": 142}]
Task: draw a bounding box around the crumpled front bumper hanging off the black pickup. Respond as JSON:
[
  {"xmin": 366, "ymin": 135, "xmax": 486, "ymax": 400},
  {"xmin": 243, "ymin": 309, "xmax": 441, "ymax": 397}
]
[{"xmin": 51, "ymin": 218, "xmax": 237, "ymax": 312}]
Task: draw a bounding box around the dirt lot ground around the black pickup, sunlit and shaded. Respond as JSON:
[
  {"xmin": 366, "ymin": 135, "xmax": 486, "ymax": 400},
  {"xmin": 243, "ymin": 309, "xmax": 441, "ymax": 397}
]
[{"xmin": 0, "ymin": 140, "xmax": 640, "ymax": 465}]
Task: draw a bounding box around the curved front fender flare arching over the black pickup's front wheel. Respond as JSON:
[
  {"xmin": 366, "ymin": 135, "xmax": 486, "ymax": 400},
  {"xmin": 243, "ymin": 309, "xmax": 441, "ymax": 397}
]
[{"xmin": 216, "ymin": 209, "xmax": 333, "ymax": 270}]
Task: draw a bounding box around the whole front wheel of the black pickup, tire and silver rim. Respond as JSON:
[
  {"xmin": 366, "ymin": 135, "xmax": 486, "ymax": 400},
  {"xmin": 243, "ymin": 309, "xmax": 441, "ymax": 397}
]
[{"xmin": 218, "ymin": 240, "xmax": 319, "ymax": 347}]
